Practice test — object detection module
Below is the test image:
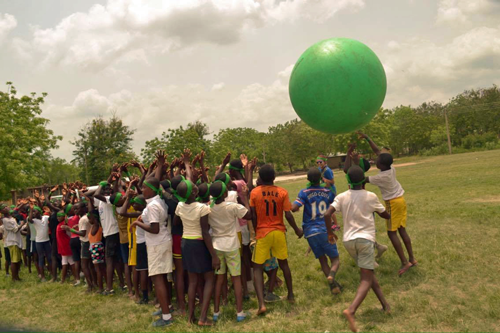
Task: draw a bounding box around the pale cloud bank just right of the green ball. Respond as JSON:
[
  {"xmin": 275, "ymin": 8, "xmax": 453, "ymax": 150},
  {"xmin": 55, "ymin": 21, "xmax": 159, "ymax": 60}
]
[{"xmin": 384, "ymin": 27, "xmax": 500, "ymax": 106}]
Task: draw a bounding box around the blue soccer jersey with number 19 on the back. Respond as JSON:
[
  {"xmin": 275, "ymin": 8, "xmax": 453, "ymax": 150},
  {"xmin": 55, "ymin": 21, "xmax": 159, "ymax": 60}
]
[{"xmin": 295, "ymin": 186, "xmax": 335, "ymax": 238}]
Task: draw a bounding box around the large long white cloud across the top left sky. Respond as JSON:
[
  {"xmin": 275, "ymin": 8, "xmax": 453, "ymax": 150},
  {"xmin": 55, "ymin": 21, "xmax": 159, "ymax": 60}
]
[{"xmin": 14, "ymin": 0, "xmax": 364, "ymax": 72}]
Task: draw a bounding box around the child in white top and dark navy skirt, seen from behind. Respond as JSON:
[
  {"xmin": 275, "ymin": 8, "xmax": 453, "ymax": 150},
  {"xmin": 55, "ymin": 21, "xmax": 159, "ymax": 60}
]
[{"xmin": 174, "ymin": 180, "xmax": 220, "ymax": 326}]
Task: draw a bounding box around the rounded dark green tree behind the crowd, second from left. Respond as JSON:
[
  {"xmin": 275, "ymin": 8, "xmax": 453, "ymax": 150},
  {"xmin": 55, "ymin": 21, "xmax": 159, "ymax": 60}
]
[{"xmin": 71, "ymin": 115, "xmax": 136, "ymax": 184}]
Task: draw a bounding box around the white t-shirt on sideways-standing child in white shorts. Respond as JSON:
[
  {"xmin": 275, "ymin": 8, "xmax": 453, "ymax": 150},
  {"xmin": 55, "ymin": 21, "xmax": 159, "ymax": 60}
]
[{"xmin": 141, "ymin": 195, "xmax": 172, "ymax": 246}]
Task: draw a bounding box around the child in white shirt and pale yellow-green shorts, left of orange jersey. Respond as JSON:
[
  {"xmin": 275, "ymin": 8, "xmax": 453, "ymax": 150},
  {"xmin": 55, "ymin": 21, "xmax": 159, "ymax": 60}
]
[{"xmin": 208, "ymin": 181, "xmax": 251, "ymax": 322}]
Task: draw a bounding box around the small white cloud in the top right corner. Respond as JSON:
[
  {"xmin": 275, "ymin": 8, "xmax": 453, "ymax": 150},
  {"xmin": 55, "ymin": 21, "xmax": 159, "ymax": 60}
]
[{"xmin": 436, "ymin": 0, "xmax": 498, "ymax": 24}]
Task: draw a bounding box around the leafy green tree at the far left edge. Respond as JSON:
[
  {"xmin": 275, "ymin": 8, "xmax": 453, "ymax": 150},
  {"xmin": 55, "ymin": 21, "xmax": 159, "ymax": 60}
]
[{"xmin": 0, "ymin": 82, "xmax": 62, "ymax": 199}]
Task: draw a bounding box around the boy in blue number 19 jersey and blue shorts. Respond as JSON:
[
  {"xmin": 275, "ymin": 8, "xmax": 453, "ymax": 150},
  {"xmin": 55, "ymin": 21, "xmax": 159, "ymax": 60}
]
[{"xmin": 292, "ymin": 168, "xmax": 341, "ymax": 295}]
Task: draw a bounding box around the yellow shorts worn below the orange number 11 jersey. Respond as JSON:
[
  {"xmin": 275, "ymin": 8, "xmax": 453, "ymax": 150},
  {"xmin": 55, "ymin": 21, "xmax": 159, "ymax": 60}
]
[{"xmin": 252, "ymin": 230, "xmax": 288, "ymax": 265}]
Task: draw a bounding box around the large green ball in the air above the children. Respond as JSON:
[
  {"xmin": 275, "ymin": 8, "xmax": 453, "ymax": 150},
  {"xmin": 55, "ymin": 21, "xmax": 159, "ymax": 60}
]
[{"xmin": 288, "ymin": 38, "xmax": 387, "ymax": 134}]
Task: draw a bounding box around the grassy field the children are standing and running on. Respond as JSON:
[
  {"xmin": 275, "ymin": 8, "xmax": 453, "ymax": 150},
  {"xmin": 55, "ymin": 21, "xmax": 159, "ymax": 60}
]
[{"xmin": 0, "ymin": 150, "xmax": 500, "ymax": 332}]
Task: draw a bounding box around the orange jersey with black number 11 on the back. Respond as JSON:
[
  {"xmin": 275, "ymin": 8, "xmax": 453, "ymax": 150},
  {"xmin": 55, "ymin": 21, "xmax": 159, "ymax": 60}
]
[{"xmin": 250, "ymin": 185, "xmax": 292, "ymax": 239}]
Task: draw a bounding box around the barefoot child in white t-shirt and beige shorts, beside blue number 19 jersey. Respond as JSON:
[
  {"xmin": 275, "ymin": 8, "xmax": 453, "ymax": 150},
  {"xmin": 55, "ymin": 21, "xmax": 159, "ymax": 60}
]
[{"xmin": 325, "ymin": 165, "xmax": 391, "ymax": 332}]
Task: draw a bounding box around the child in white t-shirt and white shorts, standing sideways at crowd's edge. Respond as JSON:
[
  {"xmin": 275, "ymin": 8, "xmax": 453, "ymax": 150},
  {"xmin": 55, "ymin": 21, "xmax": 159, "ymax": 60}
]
[{"xmin": 130, "ymin": 174, "xmax": 173, "ymax": 327}]
